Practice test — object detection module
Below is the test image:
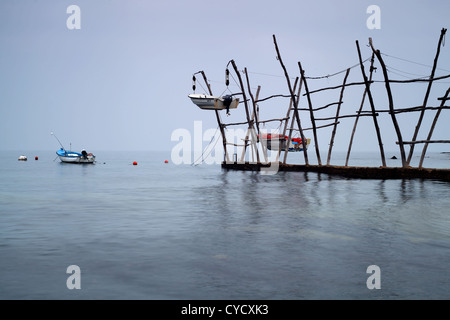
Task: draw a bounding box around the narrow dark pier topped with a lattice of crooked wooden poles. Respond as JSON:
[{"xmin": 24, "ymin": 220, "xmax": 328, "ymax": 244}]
[{"xmin": 193, "ymin": 28, "xmax": 450, "ymax": 181}]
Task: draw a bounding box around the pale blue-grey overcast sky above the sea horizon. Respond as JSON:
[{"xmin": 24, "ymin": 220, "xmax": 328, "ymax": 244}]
[{"xmin": 0, "ymin": 0, "xmax": 450, "ymax": 152}]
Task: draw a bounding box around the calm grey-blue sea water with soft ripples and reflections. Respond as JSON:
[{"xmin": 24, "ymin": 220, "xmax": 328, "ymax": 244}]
[{"xmin": 0, "ymin": 151, "xmax": 450, "ymax": 300}]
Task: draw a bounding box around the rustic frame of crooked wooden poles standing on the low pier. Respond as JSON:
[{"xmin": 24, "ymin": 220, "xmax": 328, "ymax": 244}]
[{"xmin": 192, "ymin": 28, "xmax": 450, "ymax": 181}]
